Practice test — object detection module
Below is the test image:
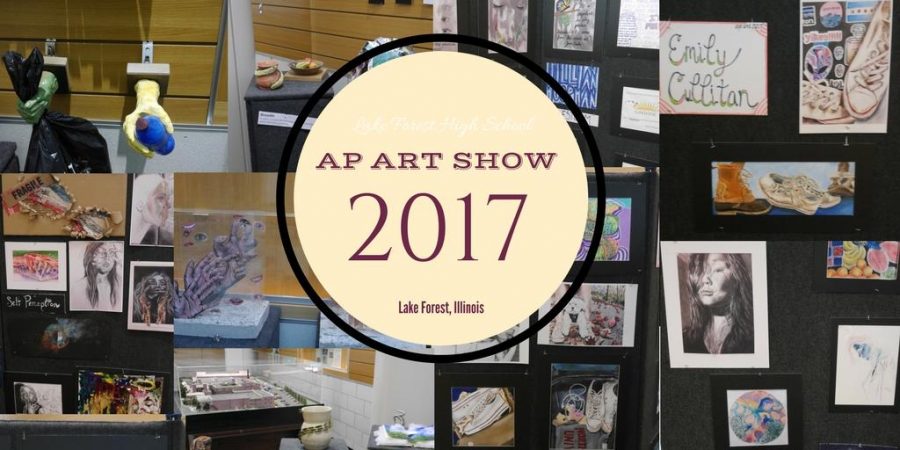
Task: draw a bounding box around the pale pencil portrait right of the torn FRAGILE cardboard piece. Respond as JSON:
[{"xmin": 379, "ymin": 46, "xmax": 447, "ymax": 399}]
[{"xmin": 130, "ymin": 173, "xmax": 175, "ymax": 247}]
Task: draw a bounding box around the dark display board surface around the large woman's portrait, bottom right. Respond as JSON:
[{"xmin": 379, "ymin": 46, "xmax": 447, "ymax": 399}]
[{"xmin": 660, "ymin": 241, "xmax": 900, "ymax": 449}]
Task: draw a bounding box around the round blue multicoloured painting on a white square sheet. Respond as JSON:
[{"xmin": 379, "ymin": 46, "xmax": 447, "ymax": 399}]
[{"xmin": 726, "ymin": 389, "xmax": 790, "ymax": 447}]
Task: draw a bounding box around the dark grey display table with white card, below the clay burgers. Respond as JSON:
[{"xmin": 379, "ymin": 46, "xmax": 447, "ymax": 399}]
[{"xmin": 244, "ymin": 80, "xmax": 334, "ymax": 172}]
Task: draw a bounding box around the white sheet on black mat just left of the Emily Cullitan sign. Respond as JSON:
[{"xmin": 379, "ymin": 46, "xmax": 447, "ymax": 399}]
[{"xmin": 610, "ymin": 77, "xmax": 659, "ymax": 141}]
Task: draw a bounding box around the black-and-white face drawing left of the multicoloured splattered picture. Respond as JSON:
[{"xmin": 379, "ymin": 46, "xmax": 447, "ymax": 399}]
[{"xmin": 4, "ymin": 372, "xmax": 75, "ymax": 414}]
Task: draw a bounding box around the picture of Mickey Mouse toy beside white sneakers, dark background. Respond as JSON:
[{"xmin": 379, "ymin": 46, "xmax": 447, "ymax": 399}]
[{"xmin": 550, "ymin": 364, "xmax": 619, "ymax": 450}]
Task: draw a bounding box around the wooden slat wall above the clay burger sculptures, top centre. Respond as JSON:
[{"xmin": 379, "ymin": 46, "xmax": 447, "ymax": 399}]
[{"xmin": 250, "ymin": 0, "xmax": 432, "ymax": 68}]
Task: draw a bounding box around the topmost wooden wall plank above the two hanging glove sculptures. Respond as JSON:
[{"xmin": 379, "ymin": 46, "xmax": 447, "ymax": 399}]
[{"xmin": 0, "ymin": 0, "xmax": 222, "ymax": 43}]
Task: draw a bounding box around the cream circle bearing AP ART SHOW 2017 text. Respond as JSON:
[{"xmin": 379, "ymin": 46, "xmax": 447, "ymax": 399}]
[{"xmin": 293, "ymin": 52, "xmax": 588, "ymax": 345}]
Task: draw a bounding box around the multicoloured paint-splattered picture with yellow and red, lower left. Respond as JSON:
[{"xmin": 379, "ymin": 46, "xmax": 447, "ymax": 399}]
[{"xmin": 78, "ymin": 370, "xmax": 164, "ymax": 414}]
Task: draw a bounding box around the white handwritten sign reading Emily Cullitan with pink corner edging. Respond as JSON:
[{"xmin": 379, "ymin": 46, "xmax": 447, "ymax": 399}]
[{"xmin": 659, "ymin": 22, "xmax": 769, "ymax": 116}]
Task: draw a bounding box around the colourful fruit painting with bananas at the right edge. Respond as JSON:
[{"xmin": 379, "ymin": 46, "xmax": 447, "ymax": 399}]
[{"xmin": 825, "ymin": 241, "xmax": 900, "ymax": 281}]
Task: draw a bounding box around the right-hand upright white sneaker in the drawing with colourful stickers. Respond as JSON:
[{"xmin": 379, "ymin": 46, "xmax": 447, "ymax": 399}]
[{"xmin": 843, "ymin": 0, "xmax": 891, "ymax": 119}]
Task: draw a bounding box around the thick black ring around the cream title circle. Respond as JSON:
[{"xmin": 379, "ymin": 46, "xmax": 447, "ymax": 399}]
[{"xmin": 275, "ymin": 34, "xmax": 606, "ymax": 364}]
